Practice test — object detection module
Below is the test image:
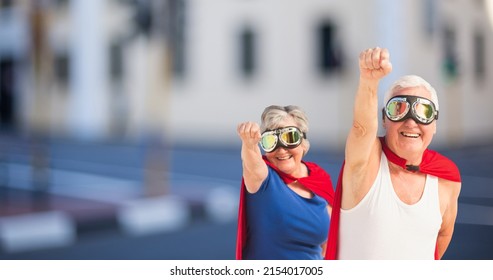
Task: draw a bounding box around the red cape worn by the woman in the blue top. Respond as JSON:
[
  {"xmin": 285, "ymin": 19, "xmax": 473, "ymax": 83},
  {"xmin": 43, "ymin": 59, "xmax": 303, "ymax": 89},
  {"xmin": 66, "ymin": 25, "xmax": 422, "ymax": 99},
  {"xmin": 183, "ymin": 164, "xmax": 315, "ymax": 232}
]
[{"xmin": 236, "ymin": 156, "xmax": 334, "ymax": 260}]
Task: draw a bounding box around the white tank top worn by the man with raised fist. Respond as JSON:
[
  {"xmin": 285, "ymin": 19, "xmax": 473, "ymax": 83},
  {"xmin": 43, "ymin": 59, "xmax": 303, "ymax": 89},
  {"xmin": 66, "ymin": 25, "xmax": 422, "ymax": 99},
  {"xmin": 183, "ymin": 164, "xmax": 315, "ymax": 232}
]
[{"xmin": 338, "ymin": 152, "xmax": 442, "ymax": 260}]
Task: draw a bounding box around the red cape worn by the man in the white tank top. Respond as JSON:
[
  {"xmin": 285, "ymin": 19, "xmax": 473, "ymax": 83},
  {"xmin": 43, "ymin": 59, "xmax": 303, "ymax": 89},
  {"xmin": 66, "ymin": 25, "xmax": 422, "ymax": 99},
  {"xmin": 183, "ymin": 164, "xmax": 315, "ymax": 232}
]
[{"xmin": 326, "ymin": 137, "xmax": 461, "ymax": 260}]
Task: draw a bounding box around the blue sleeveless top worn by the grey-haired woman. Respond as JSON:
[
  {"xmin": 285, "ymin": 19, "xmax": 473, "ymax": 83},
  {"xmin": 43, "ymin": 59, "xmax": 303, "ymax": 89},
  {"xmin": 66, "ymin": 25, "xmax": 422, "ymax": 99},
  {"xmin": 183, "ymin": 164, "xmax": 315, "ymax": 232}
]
[{"xmin": 243, "ymin": 167, "xmax": 330, "ymax": 260}]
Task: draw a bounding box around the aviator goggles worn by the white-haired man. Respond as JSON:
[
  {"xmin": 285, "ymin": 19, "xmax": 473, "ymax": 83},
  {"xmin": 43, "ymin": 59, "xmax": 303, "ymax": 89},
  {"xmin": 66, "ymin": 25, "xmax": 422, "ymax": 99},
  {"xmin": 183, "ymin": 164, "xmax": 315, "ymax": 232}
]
[{"xmin": 383, "ymin": 95, "xmax": 438, "ymax": 125}]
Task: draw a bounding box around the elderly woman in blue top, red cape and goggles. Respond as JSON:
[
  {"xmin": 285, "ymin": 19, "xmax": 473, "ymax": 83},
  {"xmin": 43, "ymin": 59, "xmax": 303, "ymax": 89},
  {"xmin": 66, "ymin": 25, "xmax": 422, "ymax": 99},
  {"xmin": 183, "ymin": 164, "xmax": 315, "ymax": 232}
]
[{"xmin": 236, "ymin": 105, "xmax": 334, "ymax": 260}]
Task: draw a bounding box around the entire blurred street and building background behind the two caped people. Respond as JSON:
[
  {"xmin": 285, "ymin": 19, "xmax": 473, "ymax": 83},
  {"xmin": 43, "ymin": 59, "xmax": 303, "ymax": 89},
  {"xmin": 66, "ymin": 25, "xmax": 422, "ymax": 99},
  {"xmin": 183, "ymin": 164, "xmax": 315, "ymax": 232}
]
[{"xmin": 0, "ymin": 0, "xmax": 493, "ymax": 260}]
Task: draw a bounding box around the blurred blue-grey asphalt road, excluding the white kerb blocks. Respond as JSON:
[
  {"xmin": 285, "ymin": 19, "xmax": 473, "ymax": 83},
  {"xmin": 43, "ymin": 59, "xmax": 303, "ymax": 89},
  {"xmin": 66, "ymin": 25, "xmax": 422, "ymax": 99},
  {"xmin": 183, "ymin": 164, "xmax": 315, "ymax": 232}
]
[{"xmin": 0, "ymin": 138, "xmax": 493, "ymax": 260}]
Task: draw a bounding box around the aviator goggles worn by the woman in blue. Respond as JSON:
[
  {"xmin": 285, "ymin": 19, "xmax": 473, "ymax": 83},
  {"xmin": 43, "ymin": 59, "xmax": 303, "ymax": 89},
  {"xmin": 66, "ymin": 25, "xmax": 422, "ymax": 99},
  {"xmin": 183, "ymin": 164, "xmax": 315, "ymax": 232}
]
[{"xmin": 260, "ymin": 126, "xmax": 306, "ymax": 153}]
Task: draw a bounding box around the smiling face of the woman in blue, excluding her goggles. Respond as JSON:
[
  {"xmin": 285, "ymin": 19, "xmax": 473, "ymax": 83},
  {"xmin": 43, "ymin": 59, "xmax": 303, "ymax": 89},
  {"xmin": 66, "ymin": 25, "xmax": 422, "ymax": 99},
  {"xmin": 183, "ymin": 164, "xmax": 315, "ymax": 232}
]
[{"xmin": 265, "ymin": 117, "xmax": 306, "ymax": 177}]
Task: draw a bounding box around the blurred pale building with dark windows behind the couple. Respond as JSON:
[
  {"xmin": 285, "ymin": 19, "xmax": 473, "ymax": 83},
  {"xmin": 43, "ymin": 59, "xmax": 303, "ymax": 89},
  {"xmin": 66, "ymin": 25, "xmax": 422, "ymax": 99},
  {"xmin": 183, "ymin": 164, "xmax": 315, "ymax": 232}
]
[{"xmin": 0, "ymin": 0, "xmax": 493, "ymax": 149}]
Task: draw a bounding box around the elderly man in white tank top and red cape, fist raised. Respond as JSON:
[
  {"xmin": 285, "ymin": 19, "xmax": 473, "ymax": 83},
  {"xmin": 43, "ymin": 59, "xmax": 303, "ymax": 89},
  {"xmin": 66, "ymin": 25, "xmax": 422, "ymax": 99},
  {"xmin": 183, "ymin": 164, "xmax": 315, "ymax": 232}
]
[{"xmin": 328, "ymin": 48, "xmax": 461, "ymax": 259}]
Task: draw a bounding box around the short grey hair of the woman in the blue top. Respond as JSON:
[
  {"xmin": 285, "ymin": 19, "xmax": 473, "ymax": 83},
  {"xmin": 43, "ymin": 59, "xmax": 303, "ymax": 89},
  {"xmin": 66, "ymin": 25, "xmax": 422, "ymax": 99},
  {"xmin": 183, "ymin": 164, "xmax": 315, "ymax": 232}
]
[{"xmin": 260, "ymin": 105, "xmax": 310, "ymax": 154}]
